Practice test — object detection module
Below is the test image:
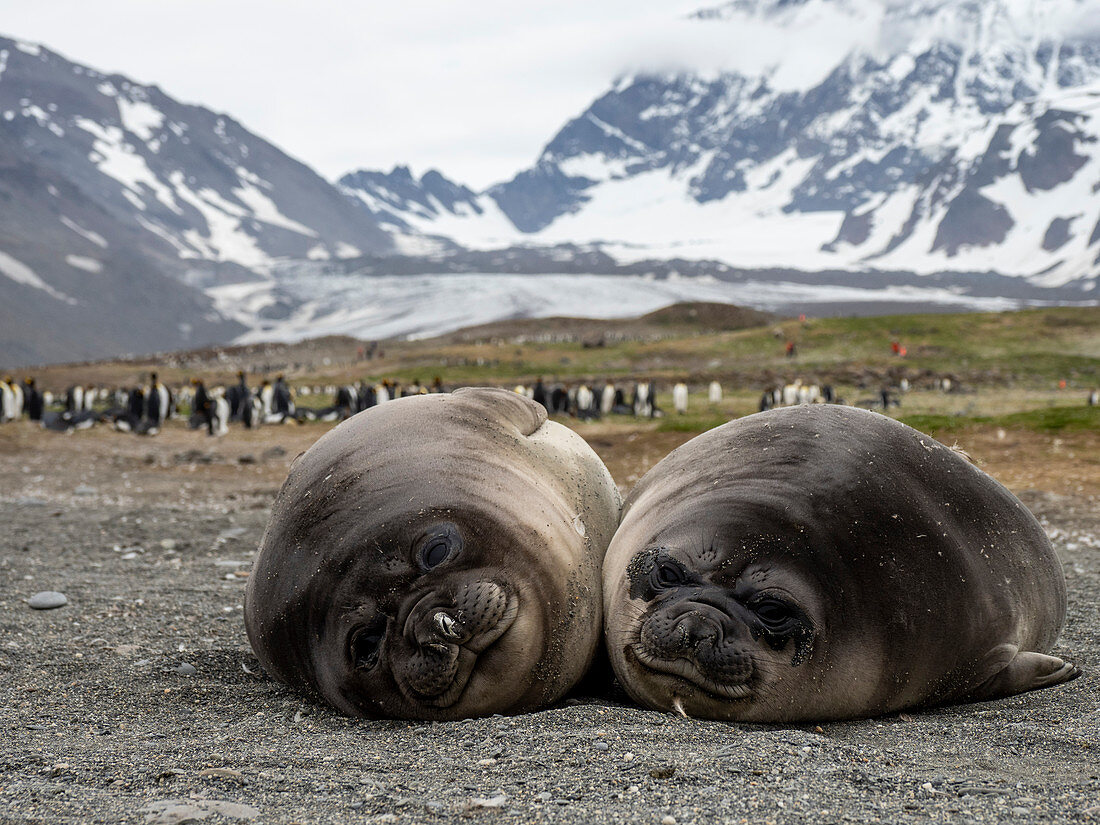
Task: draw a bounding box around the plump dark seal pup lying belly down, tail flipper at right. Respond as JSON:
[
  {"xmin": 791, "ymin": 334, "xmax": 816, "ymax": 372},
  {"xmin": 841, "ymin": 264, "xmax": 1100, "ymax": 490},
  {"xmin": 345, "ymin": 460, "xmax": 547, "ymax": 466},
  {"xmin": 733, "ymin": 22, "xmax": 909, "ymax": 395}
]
[{"xmin": 604, "ymin": 406, "xmax": 1078, "ymax": 722}]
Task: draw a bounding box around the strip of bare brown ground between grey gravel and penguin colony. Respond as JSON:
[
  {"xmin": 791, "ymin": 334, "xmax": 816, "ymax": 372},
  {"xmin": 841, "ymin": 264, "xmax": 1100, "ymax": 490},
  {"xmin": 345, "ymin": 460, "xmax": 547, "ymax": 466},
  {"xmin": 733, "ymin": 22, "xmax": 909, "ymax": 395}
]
[{"xmin": 0, "ymin": 420, "xmax": 1100, "ymax": 506}]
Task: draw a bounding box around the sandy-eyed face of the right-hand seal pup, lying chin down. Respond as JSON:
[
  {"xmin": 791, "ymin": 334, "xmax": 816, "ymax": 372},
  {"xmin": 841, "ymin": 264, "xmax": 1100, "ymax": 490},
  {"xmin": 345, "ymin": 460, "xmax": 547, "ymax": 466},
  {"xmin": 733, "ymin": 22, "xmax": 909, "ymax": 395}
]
[{"xmin": 604, "ymin": 497, "xmax": 828, "ymax": 719}]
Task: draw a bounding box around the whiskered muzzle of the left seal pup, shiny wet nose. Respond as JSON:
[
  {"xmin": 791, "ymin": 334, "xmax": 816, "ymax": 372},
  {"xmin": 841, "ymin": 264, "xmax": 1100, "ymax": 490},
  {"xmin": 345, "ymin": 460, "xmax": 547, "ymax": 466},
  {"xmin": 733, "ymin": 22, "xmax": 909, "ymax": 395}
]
[{"xmin": 398, "ymin": 585, "xmax": 519, "ymax": 708}]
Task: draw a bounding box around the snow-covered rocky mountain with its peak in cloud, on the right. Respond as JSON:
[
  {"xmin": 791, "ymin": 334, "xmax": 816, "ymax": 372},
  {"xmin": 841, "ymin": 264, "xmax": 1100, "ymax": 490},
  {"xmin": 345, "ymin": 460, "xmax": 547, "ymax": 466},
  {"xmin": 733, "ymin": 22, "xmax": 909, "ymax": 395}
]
[{"xmin": 341, "ymin": 0, "xmax": 1100, "ymax": 295}]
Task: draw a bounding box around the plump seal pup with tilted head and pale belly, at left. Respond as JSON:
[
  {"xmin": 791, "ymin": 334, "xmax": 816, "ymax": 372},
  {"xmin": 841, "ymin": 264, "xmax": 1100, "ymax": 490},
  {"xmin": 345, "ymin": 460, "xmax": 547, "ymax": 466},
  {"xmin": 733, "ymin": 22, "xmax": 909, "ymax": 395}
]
[{"xmin": 244, "ymin": 389, "xmax": 622, "ymax": 719}]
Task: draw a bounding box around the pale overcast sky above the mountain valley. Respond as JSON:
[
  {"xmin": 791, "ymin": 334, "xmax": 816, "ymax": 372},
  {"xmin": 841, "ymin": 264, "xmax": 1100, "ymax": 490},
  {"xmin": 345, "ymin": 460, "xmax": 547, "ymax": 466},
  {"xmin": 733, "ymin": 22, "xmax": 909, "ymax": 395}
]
[{"xmin": 0, "ymin": 0, "xmax": 716, "ymax": 188}]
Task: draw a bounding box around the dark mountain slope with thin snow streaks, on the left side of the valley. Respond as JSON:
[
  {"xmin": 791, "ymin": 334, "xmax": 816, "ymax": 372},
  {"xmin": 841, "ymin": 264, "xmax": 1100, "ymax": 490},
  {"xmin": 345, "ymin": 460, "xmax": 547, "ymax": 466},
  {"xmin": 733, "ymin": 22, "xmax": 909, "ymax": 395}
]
[{"xmin": 0, "ymin": 37, "xmax": 394, "ymax": 364}]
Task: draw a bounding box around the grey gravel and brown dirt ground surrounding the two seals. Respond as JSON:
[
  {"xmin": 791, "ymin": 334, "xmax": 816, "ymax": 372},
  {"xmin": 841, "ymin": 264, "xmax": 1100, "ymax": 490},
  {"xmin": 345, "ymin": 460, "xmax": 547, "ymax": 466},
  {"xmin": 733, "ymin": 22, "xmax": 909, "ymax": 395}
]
[{"xmin": 0, "ymin": 415, "xmax": 1100, "ymax": 825}]
